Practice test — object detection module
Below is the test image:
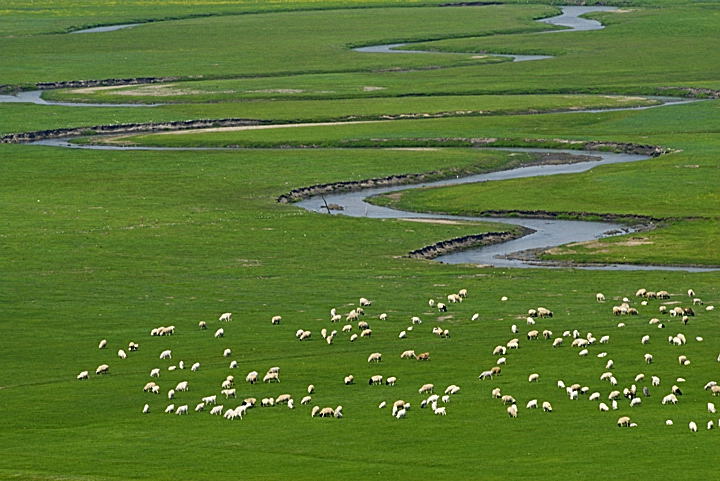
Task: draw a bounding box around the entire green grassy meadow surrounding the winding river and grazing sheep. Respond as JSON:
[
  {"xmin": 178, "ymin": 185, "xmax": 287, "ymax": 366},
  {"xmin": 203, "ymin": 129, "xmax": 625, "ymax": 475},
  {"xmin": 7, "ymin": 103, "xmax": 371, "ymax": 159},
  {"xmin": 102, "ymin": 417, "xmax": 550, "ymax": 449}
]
[{"xmin": 0, "ymin": 0, "xmax": 720, "ymax": 481}]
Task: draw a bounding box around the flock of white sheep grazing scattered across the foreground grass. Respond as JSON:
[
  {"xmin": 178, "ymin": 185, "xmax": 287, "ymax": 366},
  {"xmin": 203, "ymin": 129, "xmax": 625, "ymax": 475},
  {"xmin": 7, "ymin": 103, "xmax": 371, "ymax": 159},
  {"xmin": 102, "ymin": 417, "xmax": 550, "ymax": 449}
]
[{"xmin": 77, "ymin": 289, "xmax": 720, "ymax": 431}]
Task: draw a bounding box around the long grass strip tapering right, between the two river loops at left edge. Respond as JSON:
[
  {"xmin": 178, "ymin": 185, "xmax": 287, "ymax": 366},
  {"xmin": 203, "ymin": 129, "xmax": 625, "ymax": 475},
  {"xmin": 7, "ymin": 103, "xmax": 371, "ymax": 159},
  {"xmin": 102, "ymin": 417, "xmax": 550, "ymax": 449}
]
[{"xmin": 0, "ymin": 95, "xmax": 658, "ymax": 134}]
